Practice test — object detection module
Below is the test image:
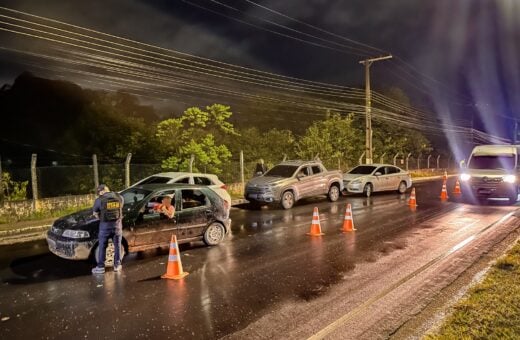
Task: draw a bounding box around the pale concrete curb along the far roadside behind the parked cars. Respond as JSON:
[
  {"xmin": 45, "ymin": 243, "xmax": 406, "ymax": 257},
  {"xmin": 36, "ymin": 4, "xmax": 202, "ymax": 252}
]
[{"xmin": 0, "ymin": 175, "xmax": 457, "ymax": 245}]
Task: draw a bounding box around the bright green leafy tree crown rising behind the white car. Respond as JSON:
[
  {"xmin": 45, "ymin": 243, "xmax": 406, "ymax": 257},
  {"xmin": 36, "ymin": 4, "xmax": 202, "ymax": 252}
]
[{"xmin": 156, "ymin": 104, "xmax": 238, "ymax": 174}]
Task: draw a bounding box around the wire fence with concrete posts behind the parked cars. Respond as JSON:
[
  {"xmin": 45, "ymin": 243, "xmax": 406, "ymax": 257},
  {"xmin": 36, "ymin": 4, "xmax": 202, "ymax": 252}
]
[{"xmin": 3, "ymin": 152, "xmax": 458, "ymax": 199}]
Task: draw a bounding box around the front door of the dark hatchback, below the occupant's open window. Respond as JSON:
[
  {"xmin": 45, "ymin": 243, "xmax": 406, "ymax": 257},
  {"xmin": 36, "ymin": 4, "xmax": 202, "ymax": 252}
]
[{"xmin": 132, "ymin": 190, "xmax": 177, "ymax": 248}]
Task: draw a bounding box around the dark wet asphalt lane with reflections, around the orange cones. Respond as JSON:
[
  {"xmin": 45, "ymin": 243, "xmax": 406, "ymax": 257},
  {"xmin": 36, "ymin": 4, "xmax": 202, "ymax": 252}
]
[{"xmin": 0, "ymin": 181, "xmax": 516, "ymax": 339}]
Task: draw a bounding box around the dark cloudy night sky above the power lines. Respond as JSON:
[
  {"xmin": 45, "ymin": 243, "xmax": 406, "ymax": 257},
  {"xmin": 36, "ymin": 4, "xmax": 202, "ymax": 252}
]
[{"xmin": 0, "ymin": 0, "xmax": 520, "ymax": 141}]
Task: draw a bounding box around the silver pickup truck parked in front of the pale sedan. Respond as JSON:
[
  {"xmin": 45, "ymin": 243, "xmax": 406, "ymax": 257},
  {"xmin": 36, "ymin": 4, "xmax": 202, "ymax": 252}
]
[{"xmin": 244, "ymin": 161, "xmax": 343, "ymax": 209}]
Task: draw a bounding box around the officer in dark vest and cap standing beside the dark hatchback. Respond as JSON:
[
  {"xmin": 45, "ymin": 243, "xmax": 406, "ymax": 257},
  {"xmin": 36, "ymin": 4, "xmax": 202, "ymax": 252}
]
[{"xmin": 92, "ymin": 184, "xmax": 124, "ymax": 274}]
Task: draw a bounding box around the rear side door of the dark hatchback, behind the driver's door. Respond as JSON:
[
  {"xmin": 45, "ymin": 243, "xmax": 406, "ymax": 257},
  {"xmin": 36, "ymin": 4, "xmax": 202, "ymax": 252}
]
[{"xmin": 176, "ymin": 189, "xmax": 214, "ymax": 240}]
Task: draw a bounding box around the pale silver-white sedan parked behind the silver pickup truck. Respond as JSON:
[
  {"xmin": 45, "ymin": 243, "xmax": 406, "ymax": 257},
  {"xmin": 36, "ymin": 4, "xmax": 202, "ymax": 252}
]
[{"xmin": 343, "ymin": 164, "xmax": 412, "ymax": 197}]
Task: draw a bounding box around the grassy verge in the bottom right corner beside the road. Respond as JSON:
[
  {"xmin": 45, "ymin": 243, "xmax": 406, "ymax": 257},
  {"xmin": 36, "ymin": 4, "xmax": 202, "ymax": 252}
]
[{"xmin": 425, "ymin": 242, "xmax": 520, "ymax": 340}]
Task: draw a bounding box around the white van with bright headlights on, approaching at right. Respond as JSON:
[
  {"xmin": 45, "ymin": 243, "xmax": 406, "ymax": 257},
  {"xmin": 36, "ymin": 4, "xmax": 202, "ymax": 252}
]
[{"xmin": 459, "ymin": 145, "xmax": 519, "ymax": 203}]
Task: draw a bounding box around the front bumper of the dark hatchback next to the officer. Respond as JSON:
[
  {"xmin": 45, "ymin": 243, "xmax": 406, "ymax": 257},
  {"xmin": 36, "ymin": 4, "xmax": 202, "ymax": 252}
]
[{"xmin": 47, "ymin": 231, "xmax": 96, "ymax": 260}]
